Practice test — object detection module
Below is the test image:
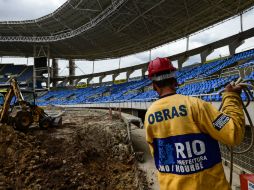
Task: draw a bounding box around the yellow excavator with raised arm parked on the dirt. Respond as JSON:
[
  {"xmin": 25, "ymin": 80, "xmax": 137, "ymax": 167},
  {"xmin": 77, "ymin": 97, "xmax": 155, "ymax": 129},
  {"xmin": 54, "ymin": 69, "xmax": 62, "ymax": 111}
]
[{"xmin": 0, "ymin": 78, "xmax": 62, "ymax": 131}]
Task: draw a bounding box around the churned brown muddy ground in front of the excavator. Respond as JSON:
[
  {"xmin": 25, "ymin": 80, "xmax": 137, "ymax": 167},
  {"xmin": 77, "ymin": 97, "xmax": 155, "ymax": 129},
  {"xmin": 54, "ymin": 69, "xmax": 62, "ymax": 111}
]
[{"xmin": 0, "ymin": 110, "xmax": 148, "ymax": 190}]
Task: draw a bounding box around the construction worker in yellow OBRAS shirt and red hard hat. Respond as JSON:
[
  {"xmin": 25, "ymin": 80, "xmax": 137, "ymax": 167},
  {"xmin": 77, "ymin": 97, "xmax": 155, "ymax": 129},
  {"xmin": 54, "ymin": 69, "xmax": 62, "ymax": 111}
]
[{"xmin": 145, "ymin": 58, "xmax": 245, "ymax": 190}]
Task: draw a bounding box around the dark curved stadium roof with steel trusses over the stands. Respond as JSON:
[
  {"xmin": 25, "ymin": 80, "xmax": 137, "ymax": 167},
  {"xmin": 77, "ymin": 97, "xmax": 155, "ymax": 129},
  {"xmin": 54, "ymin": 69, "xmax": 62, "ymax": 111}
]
[{"xmin": 0, "ymin": 0, "xmax": 254, "ymax": 60}]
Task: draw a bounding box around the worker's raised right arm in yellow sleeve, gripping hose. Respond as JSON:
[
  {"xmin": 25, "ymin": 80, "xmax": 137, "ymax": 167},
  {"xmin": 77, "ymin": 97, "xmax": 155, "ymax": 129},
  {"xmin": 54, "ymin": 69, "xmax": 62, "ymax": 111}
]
[{"xmin": 193, "ymin": 85, "xmax": 245, "ymax": 146}]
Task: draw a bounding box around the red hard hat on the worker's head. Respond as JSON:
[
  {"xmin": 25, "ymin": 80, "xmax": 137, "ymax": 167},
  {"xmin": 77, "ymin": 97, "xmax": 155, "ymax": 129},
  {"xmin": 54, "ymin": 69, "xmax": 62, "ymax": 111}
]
[{"xmin": 148, "ymin": 57, "xmax": 176, "ymax": 79}]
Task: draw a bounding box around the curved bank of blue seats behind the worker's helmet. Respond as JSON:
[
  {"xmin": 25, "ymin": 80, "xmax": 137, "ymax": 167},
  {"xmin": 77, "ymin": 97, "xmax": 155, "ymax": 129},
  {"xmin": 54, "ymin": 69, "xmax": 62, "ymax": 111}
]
[{"xmin": 38, "ymin": 49, "xmax": 254, "ymax": 105}]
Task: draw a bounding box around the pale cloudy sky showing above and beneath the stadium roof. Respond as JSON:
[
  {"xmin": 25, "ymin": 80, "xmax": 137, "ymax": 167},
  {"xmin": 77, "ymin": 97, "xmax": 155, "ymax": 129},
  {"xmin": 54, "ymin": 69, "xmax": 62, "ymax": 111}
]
[{"xmin": 0, "ymin": 0, "xmax": 254, "ymax": 81}]
